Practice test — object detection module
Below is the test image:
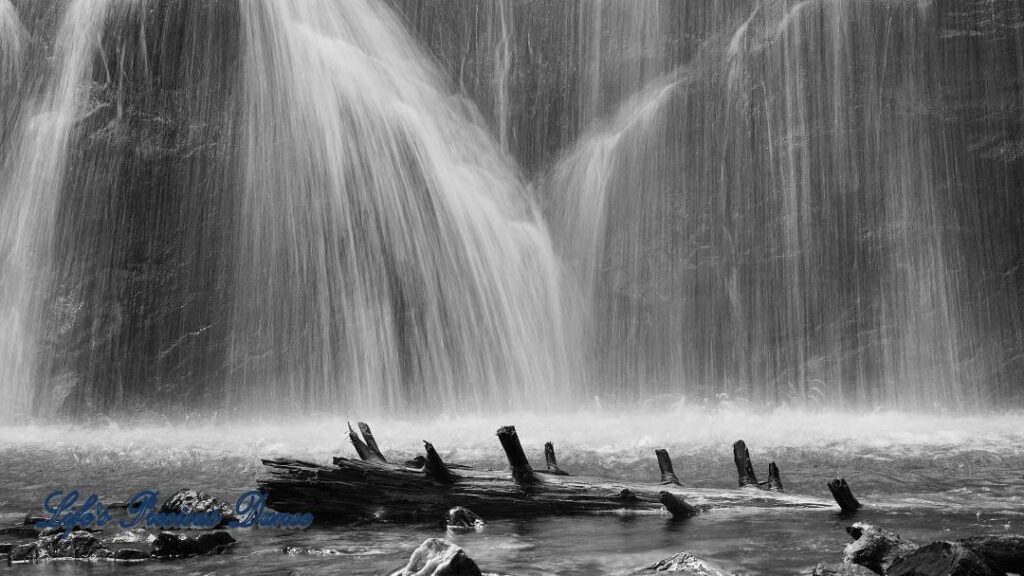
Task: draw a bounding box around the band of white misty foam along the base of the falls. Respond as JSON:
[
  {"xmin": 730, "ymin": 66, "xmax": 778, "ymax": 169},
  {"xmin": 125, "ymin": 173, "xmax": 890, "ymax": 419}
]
[{"xmin": 0, "ymin": 408, "xmax": 1024, "ymax": 461}]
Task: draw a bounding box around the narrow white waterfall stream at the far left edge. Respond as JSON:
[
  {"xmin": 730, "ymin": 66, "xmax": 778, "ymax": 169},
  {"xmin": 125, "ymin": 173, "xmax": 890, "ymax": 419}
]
[{"xmin": 0, "ymin": 0, "xmax": 119, "ymax": 415}]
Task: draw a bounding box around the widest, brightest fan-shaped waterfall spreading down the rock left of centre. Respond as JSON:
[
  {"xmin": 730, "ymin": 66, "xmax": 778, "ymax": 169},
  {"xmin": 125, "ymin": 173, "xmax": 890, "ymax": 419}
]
[{"xmin": 228, "ymin": 0, "xmax": 568, "ymax": 410}]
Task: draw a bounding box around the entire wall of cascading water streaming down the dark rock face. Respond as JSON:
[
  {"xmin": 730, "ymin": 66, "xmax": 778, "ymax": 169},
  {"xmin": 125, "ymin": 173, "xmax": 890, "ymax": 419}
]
[{"xmin": 0, "ymin": 0, "xmax": 1024, "ymax": 416}]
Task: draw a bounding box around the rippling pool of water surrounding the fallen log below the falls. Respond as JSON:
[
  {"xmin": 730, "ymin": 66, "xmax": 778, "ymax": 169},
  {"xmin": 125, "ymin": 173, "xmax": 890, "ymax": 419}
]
[{"xmin": 0, "ymin": 409, "xmax": 1024, "ymax": 576}]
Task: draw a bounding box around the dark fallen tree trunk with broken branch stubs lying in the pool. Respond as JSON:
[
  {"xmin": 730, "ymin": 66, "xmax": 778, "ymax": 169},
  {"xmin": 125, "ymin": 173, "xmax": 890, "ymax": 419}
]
[{"xmin": 258, "ymin": 423, "xmax": 847, "ymax": 522}]
